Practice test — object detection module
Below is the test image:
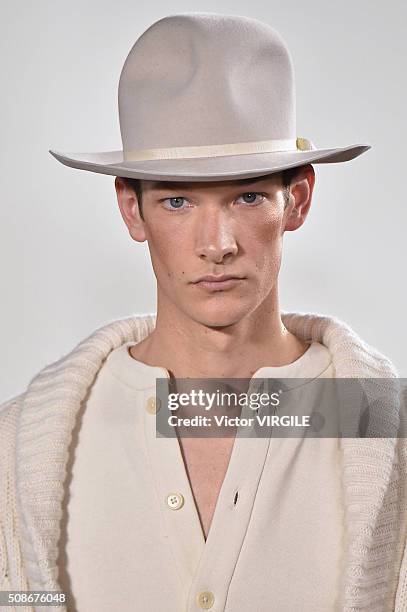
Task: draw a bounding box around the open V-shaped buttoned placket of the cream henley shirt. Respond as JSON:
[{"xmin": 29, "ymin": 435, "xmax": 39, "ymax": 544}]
[{"xmin": 145, "ymin": 381, "xmax": 270, "ymax": 612}]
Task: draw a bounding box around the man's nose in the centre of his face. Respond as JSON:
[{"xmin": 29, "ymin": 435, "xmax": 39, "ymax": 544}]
[{"xmin": 195, "ymin": 207, "xmax": 238, "ymax": 263}]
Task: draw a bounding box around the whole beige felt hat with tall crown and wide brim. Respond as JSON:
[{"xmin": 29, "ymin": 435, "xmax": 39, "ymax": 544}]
[{"xmin": 50, "ymin": 13, "xmax": 370, "ymax": 181}]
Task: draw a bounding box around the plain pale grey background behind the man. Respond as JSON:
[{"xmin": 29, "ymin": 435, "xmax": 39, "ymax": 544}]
[{"xmin": 0, "ymin": 0, "xmax": 407, "ymax": 401}]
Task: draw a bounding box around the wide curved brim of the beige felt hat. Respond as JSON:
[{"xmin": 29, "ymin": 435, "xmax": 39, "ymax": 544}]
[{"xmin": 50, "ymin": 145, "xmax": 371, "ymax": 181}]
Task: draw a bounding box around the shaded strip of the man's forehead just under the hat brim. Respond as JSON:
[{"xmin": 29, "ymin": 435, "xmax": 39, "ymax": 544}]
[{"xmin": 141, "ymin": 173, "xmax": 280, "ymax": 192}]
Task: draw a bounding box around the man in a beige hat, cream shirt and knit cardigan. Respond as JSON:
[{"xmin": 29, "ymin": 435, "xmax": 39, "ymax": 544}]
[{"xmin": 1, "ymin": 9, "xmax": 407, "ymax": 612}]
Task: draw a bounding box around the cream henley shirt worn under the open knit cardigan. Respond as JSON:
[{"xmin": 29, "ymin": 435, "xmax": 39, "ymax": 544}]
[{"xmin": 59, "ymin": 342, "xmax": 345, "ymax": 612}]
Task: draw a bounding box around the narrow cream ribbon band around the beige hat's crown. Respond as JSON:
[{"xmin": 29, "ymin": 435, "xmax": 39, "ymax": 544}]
[{"xmin": 123, "ymin": 138, "xmax": 315, "ymax": 161}]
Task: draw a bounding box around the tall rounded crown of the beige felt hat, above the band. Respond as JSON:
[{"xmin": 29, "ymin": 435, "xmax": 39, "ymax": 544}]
[{"xmin": 119, "ymin": 13, "xmax": 296, "ymax": 151}]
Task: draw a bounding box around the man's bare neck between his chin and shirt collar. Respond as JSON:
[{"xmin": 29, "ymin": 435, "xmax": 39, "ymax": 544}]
[{"xmin": 131, "ymin": 291, "xmax": 309, "ymax": 378}]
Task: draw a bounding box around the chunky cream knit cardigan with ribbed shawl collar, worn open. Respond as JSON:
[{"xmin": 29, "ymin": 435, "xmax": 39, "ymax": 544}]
[{"xmin": 0, "ymin": 313, "xmax": 407, "ymax": 612}]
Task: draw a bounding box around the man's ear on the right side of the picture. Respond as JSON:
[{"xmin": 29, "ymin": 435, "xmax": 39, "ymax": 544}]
[{"xmin": 284, "ymin": 164, "xmax": 315, "ymax": 232}]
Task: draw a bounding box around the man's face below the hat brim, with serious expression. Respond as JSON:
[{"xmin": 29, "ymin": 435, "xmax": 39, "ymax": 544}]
[{"xmin": 116, "ymin": 170, "xmax": 314, "ymax": 326}]
